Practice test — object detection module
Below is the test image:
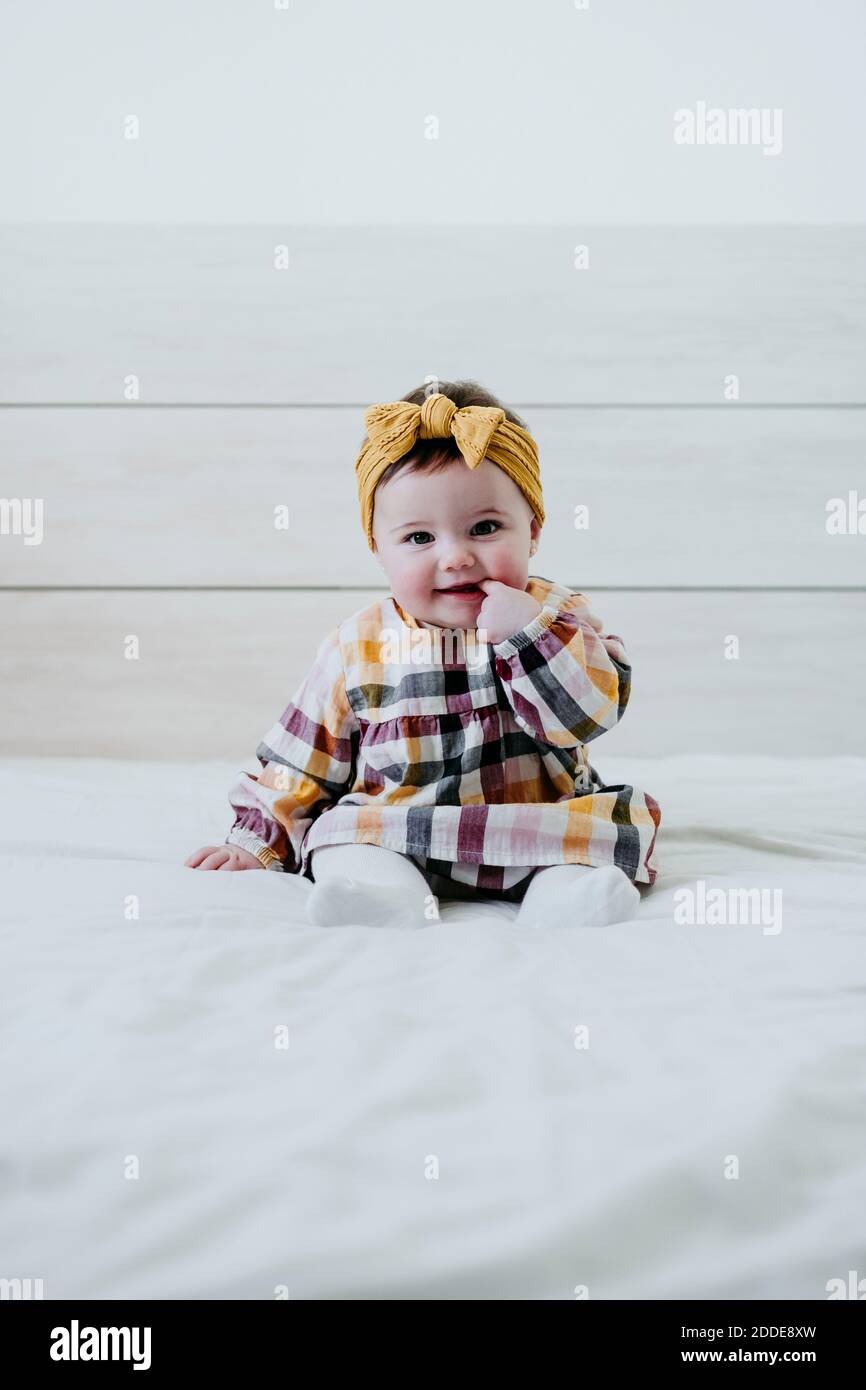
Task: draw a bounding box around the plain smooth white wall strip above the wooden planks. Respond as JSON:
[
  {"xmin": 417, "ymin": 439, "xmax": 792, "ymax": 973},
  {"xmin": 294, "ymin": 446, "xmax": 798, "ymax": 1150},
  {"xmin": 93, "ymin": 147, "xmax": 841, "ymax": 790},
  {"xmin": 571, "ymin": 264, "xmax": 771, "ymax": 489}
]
[{"xmin": 0, "ymin": 0, "xmax": 866, "ymax": 225}]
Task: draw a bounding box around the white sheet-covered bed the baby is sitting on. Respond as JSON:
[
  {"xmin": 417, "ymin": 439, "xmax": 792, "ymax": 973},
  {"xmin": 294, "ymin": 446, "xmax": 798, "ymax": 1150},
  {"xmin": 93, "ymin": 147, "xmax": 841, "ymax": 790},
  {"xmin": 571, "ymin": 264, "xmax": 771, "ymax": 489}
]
[{"xmin": 0, "ymin": 749, "xmax": 866, "ymax": 1300}]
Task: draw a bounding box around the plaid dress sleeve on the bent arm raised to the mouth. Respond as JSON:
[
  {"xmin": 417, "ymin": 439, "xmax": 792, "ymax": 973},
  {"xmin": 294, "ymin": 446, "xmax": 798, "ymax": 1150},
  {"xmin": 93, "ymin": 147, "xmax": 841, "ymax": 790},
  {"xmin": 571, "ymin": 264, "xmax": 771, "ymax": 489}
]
[{"xmin": 492, "ymin": 594, "xmax": 631, "ymax": 748}]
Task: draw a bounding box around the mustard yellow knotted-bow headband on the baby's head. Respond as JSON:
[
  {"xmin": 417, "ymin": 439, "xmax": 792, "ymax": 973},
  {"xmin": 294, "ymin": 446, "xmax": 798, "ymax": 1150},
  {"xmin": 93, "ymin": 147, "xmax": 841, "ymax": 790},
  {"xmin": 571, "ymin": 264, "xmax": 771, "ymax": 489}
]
[{"xmin": 354, "ymin": 392, "xmax": 545, "ymax": 549}]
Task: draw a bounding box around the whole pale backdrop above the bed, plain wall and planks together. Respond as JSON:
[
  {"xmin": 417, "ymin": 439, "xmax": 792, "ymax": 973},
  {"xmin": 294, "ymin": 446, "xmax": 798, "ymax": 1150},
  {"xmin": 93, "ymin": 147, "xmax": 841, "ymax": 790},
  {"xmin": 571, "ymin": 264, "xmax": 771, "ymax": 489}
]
[{"xmin": 0, "ymin": 0, "xmax": 866, "ymax": 756}]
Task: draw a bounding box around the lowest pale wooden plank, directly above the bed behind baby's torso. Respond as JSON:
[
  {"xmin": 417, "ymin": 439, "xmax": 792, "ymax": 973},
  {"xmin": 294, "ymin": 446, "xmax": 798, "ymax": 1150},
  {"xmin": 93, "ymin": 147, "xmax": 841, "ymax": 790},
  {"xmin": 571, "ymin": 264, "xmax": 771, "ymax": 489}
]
[{"xmin": 0, "ymin": 589, "xmax": 866, "ymax": 773}]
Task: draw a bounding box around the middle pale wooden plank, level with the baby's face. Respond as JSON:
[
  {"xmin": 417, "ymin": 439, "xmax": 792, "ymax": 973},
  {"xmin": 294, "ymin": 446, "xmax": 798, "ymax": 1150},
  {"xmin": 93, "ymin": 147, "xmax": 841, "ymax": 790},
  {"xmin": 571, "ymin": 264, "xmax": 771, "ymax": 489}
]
[{"xmin": 0, "ymin": 404, "xmax": 866, "ymax": 587}]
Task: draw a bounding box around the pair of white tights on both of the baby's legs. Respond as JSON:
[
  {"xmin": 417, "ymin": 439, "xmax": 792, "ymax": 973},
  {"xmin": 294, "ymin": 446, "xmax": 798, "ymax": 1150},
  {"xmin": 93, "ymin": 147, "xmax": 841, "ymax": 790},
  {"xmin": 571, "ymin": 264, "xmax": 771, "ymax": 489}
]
[{"xmin": 307, "ymin": 844, "xmax": 641, "ymax": 927}]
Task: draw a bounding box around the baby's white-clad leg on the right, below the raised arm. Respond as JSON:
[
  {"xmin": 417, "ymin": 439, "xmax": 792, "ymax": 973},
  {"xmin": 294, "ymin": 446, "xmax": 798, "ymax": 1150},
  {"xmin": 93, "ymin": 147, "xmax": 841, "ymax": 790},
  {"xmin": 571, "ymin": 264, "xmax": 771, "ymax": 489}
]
[{"xmin": 514, "ymin": 865, "xmax": 641, "ymax": 927}]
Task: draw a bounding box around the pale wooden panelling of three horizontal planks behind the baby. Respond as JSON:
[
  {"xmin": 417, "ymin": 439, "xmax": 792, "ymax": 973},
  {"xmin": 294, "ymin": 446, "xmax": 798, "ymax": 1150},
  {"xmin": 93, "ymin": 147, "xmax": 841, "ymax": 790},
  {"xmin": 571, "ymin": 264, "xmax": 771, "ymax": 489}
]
[{"xmin": 0, "ymin": 227, "xmax": 866, "ymax": 770}]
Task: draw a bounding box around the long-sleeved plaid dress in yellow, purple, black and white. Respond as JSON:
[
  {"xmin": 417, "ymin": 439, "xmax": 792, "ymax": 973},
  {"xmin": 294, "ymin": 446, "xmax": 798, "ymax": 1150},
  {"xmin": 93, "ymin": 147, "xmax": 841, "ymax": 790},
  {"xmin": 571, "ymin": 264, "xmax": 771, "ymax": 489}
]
[{"xmin": 225, "ymin": 575, "xmax": 660, "ymax": 902}]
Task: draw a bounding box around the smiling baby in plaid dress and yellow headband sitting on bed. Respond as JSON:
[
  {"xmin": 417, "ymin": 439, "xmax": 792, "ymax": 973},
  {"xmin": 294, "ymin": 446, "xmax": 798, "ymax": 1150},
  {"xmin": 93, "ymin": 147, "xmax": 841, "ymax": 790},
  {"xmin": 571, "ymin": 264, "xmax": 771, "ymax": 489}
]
[{"xmin": 186, "ymin": 381, "xmax": 660, "ymax": 927}]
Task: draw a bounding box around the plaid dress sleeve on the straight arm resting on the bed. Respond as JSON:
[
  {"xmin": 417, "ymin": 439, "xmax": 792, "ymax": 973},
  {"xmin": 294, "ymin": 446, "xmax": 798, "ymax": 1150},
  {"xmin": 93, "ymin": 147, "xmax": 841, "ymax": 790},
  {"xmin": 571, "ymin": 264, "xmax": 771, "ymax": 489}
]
[{"xmin": 225, "ymin": 628, "xmax": 359, "ymax": 873}]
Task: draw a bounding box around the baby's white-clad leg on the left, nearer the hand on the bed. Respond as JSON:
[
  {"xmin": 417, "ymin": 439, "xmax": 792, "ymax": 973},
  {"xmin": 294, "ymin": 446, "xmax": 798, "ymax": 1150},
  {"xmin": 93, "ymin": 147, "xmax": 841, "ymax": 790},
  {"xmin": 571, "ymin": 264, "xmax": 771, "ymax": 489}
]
[{"xmin": 307, "ymin": 844, "xmax": 432, "ymax": 927}]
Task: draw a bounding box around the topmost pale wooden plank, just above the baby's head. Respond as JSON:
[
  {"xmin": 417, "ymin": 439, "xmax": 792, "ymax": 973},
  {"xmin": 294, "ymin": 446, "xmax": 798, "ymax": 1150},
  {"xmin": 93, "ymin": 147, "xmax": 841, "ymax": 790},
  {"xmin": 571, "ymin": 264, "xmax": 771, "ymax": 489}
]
[{"xmin": 0, "ymin": 224, "xmax": 866, "ymax": 409}]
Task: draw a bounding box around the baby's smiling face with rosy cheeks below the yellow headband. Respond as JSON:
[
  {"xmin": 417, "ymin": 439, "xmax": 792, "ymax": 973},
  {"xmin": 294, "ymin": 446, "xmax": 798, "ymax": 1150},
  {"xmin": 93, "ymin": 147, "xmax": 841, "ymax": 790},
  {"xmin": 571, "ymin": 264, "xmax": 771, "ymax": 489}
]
[{"xmin": 373, "ymin": 459, "xmax": 541, "ymax": 628}]
